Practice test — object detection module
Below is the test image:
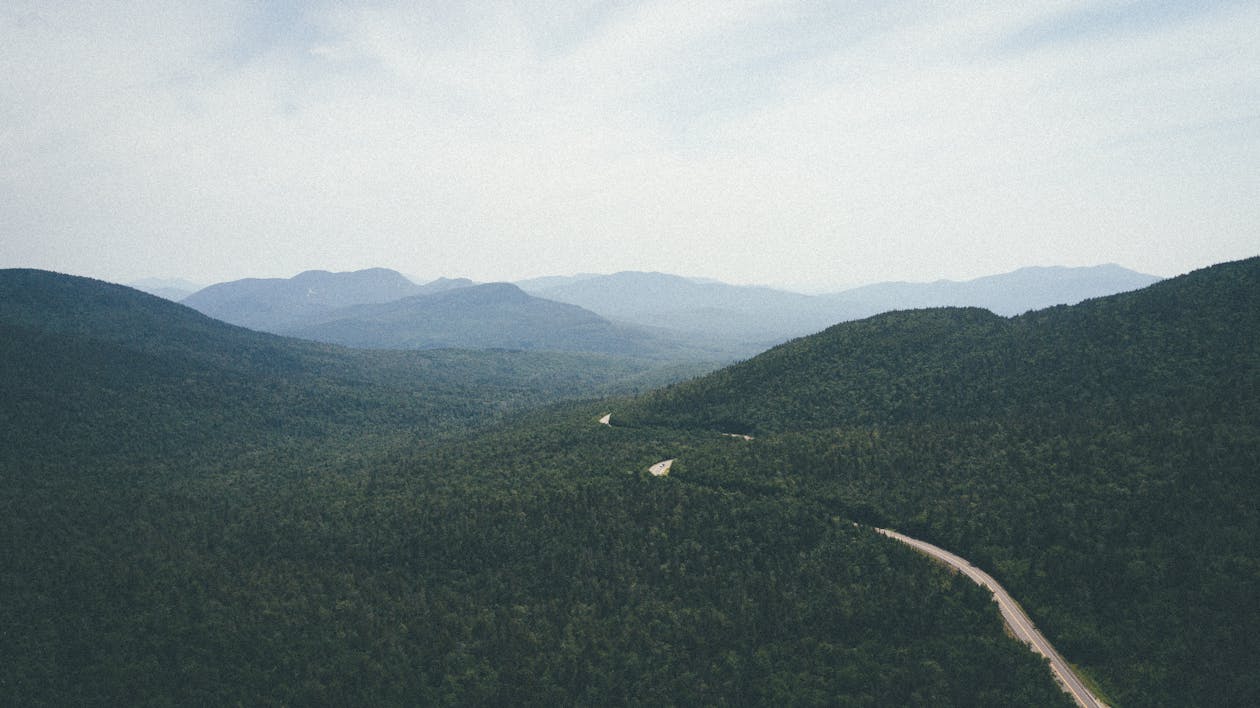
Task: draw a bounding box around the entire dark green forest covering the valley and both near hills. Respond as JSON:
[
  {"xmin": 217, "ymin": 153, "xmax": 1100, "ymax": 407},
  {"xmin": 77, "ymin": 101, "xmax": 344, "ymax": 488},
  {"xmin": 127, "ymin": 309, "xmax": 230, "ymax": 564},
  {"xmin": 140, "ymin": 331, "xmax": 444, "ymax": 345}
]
[{"xmin": 0, "ymin": 260, "xmax": 1260, "ymax": 705}]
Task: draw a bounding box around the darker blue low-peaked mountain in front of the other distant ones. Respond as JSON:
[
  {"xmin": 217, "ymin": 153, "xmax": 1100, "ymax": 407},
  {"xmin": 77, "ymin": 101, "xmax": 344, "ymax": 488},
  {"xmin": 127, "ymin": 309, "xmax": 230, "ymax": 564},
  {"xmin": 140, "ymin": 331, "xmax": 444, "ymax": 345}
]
[{"xmin": 278, "ymin": 282, "xmax": 695, "ymax": 357}]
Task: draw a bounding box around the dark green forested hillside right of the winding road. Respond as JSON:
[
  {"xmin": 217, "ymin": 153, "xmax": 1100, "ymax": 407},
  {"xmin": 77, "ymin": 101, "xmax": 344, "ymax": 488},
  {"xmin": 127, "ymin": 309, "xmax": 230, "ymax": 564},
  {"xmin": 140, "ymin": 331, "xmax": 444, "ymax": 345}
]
[{"xmin": 619, "ymin": 258, "xmax": 1260, "ymax": 705}]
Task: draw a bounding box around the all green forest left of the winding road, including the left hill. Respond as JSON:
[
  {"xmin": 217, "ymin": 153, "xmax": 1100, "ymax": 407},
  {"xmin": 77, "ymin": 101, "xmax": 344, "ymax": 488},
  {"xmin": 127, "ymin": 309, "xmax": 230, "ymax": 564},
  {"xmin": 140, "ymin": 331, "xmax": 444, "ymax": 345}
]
[{"xmin": 0, "ymin": 271, "xmax": 1068, "ymax": 705}]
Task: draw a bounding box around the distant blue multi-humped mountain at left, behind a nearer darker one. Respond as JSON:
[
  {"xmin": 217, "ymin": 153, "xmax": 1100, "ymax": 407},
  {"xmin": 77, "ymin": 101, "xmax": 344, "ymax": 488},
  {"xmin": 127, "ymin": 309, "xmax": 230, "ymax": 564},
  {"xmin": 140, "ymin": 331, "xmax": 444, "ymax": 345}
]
[{"xmin": 183, "ymin": 268, "xmax": 443, "ymax": 331}]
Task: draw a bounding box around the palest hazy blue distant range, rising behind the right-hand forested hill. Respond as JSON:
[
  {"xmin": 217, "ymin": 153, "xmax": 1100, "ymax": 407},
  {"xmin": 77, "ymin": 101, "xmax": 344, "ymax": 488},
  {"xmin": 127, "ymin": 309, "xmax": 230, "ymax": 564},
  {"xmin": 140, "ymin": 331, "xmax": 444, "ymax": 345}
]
[{"xmin": 533, "ymin": 266, "xmax": 1159, "ymax": 353}]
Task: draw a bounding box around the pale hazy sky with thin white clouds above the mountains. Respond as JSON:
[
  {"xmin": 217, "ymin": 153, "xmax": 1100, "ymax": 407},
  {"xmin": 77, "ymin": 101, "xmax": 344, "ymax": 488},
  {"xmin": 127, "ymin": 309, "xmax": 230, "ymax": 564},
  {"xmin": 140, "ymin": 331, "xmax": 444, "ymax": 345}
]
[{"xmin": 0, "ymin": 0, "xmax": 1260, "ymax": 291}]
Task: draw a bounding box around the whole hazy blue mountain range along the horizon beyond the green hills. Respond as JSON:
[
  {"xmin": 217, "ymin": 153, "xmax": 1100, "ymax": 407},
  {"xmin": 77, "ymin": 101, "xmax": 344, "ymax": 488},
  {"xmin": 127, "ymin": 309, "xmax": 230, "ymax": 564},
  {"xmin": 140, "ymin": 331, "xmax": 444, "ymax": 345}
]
[{"xmin": 183, "ymin": 266, "xmax": 1158, "ymax": 360}]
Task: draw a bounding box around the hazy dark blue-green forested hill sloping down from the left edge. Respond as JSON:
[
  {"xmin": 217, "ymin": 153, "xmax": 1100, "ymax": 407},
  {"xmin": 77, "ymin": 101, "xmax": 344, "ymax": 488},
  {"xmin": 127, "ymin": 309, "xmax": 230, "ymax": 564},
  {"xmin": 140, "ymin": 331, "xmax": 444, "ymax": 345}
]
[{"xmin": 0, "ymin": 270, "xmax": 690, "ymax": 464}]
